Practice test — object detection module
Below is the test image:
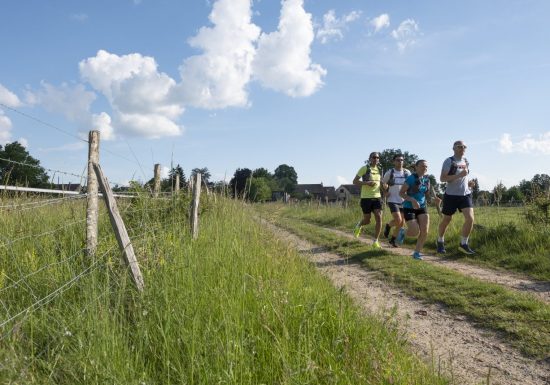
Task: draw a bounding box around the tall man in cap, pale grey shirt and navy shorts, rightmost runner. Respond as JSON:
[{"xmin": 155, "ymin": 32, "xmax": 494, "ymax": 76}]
[{"xmin": 436, "ymin": 140, "xmax": 475, "ymax": 255}]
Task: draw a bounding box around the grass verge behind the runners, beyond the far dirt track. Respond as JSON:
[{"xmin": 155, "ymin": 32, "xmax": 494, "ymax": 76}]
[{"xmin": 266, "ymin": 198, "xmax": 550, "ymax": 281}]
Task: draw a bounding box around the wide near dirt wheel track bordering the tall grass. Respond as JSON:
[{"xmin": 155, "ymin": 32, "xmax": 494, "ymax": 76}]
[{"xmin": 262, "ymin": 221, "xmax": 550, "ymax": 385}]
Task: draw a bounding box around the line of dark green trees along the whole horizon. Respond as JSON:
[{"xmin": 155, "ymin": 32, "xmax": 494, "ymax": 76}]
[{"xmin": 0, "ymin": 141, "xmax": 550, "ymax": 204}]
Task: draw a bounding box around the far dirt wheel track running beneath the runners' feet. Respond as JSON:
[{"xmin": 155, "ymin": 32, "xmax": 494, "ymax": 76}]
[{"xmin": 323, "ymin": 227, "xmax": 550, "ymax": 304}]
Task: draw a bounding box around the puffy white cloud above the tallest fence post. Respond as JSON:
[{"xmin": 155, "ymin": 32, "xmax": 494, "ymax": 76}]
[{"xmin": 79, "ymin": 50, "xmax": 184, "ymax": 138}]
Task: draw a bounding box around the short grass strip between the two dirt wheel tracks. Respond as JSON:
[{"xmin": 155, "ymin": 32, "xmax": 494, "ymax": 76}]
[{"xmin": 257, "ymin": 204, "xmax": 550, "ymax": 359}]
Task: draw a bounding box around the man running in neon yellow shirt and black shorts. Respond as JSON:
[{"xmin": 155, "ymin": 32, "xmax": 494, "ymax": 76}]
[{"xmin": 353, "ymin": 152, "xmax": 382, "ymax": 249}]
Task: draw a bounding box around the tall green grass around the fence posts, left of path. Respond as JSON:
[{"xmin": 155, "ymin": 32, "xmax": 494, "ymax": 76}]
[{"xmin": 0, "ymin": 198, "xmax": 448, "ymax": 385}]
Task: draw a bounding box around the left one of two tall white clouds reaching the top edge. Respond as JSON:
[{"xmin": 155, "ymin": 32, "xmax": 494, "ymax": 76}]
[{"xmin": 178, "ymin": 0, "xmax": 260, "ymax": 109}]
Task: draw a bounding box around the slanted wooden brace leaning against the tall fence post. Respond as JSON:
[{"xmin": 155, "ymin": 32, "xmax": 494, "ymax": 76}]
[{"xmin": 93, "ymin": 163, "xmax": 145, "ymax": 291}]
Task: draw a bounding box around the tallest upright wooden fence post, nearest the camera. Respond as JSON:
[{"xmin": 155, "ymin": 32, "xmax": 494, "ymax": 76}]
[{"xmin": 86, "ymin": 131, "xmax": 99, "ymax": 256}]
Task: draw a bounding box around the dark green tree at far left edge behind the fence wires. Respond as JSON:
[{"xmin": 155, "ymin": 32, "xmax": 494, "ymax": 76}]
[{"xmin": 0, "ymin": 142, "xmax": 48, "ymax": 187}]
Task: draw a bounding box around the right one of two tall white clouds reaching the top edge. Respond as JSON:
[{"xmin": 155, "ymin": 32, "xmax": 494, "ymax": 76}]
[{"xmin": 253, "ymin": 0, "xmax": 327, "ymax": 97}]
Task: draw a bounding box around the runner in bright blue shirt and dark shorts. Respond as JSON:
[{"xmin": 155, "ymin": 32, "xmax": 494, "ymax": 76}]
[{"xmin": 396, "ymin": 159, "xmax": 441, "ymax": 260}]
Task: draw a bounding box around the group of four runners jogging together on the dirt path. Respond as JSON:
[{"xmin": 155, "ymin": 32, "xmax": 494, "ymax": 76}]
[{"xmin": 353, "ymin": 140, "xmax": 475, "ymax": 260}]
